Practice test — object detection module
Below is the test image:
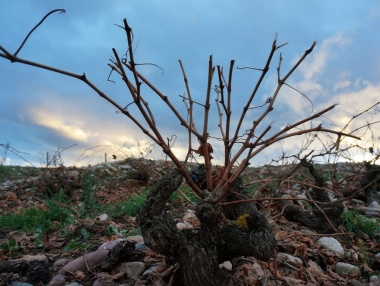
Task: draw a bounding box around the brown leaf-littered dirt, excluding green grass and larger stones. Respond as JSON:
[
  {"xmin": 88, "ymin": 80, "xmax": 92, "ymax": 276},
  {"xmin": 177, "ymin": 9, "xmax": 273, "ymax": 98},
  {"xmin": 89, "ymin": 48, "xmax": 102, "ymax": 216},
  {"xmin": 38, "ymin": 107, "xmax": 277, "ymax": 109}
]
[{"xmin": 0, "ymin": 161, "xmax": 380, "ymax": 285}]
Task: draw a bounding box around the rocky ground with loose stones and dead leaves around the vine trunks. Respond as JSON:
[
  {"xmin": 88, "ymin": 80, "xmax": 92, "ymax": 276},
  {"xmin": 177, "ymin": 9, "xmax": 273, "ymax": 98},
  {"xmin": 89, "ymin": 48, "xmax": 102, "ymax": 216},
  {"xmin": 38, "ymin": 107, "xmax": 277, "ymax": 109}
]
[{"xmin": 0, "ymin": 160, "xmax": 380, "ymax": 286}]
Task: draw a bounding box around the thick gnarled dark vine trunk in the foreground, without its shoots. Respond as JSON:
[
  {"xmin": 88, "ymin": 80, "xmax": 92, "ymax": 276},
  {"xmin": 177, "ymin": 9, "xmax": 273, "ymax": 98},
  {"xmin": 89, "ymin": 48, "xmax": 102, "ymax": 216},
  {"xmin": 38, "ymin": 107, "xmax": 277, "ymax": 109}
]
[{"xmin": 137, "ymin": 170, "xmax": 276, "ymax": 286}]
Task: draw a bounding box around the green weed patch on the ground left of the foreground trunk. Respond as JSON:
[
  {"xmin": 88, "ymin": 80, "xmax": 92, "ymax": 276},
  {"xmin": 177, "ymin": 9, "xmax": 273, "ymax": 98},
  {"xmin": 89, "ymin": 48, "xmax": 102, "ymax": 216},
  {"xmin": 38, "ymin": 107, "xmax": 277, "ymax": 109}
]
[{"xmin": 0, "ymin": 169, "xmax": 149, "ymax": 255}]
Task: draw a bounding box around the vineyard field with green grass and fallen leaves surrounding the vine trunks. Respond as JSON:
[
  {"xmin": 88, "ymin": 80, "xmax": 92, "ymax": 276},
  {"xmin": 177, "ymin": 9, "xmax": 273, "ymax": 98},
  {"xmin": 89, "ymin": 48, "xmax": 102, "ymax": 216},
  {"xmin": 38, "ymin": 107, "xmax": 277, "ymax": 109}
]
[{"xmin": 0, "ymin": 159, "xmax": 380, "ymax": 285}]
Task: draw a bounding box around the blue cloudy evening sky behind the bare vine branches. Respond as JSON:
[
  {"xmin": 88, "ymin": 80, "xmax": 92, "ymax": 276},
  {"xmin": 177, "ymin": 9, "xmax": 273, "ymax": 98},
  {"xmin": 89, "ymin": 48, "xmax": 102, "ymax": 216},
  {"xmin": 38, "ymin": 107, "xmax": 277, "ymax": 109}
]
[{"xmin": 0, "ymin": 0, "xmax": 380, "ymax": 166}]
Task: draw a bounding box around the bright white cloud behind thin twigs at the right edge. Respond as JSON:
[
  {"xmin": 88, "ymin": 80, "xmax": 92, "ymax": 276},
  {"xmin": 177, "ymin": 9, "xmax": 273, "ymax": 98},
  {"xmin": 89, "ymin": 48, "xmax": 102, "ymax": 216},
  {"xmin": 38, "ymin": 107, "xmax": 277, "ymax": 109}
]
[{"xmin": 270, "ymin": 80, "xmax": 380, "ymax": 164}]
